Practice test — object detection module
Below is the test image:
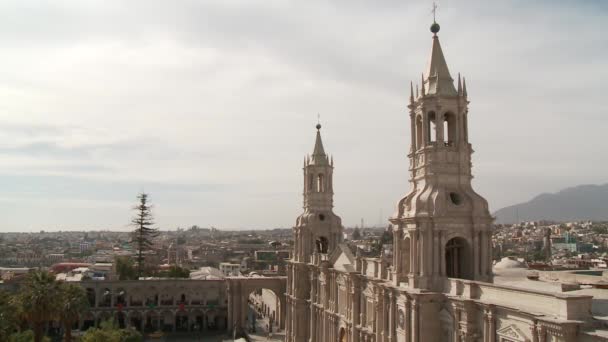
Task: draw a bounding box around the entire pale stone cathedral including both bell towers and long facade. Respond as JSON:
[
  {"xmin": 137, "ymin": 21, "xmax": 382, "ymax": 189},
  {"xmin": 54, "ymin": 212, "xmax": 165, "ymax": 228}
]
[{"xmin": 286, "ymin": 24, "xmax": 604, "ymax": 342}]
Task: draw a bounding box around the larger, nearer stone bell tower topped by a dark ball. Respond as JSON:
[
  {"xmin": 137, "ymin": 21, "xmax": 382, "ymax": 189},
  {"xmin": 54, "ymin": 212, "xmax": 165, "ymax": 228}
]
[{"xmin": 390, "ymin": 22, "xmax": 493, "ymax": 291}]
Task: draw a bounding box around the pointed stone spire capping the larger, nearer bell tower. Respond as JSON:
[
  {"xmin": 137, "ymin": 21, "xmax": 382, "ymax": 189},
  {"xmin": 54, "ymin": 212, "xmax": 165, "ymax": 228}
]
[{"xmin": 424, "ymin": 32, "xmax": 458, "ymax": 96}]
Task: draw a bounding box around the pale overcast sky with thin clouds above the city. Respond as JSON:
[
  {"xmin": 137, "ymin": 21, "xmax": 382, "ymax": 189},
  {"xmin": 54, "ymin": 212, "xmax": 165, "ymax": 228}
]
[{"xmin": 0, "ymin": 0, "xmax": 608, "ymax": 231}]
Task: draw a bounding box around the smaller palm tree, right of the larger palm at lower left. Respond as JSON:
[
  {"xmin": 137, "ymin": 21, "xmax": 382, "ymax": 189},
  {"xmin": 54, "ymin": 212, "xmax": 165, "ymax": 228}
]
[{"xmin": 59, "ymin": 283, "xmax": 89, "ymax": 342}]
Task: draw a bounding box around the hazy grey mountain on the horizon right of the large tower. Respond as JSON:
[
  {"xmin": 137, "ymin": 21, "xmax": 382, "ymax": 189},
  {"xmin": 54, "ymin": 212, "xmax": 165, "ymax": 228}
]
[{"xmin": 494, "ymin": 184, "xmax": 608, "ymax": 223}]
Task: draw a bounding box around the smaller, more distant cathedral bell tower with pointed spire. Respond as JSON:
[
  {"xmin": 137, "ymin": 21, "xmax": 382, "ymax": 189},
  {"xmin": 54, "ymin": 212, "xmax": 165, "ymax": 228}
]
[{"xmin": 293, "ymin": 124, "xmax": 342, "ymax": 262}]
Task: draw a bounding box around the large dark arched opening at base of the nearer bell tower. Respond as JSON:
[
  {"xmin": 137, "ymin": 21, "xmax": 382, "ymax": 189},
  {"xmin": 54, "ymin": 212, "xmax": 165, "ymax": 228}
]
[{"xmin": 444, "ymin": 236, "xmax": 473, "ymax": 279}]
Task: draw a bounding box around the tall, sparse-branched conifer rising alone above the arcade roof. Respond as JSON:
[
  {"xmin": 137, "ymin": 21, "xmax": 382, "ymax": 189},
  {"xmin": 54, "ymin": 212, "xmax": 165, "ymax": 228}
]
[{"xmin": 131, "ymin": 192, "xmax": 158, "ymax": 277}]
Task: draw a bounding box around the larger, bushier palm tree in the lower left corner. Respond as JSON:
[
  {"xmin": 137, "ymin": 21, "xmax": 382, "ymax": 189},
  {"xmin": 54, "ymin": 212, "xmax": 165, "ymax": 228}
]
[{"xmin": 15, "ymin": 271, "xmax": 61, "ymax": 342}]
